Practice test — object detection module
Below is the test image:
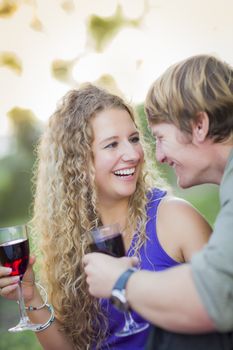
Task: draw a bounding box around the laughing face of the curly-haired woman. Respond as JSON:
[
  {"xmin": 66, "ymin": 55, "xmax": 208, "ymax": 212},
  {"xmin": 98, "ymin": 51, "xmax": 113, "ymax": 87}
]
[{"xmin": 91, "ymin": 109, "xmax": 144, "ymax": 203}]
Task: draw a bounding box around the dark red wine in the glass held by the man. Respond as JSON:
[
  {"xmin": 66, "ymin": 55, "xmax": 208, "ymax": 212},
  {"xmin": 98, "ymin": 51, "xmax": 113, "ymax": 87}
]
[{"xmin": 89, "ymin": 234, "xmax": 125, "ymax": 258}]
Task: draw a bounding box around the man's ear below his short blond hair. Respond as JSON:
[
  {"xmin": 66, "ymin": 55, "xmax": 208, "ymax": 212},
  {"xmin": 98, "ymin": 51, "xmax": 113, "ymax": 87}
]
[{"xmin": 192, "ymin": 112, "xmax": 209, "ymax": 144}]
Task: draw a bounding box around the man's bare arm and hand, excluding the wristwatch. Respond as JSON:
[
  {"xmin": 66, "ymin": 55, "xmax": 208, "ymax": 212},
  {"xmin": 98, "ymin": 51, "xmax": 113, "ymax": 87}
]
[{"xmin": 83, "ymin": 253, "xmax": 215, "ymax": 333}]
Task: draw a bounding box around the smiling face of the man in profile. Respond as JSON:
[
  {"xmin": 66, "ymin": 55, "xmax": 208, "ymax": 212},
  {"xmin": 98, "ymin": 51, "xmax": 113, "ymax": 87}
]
[{"xmin": 151, "ymin": 123, "xmax": 211, "ymax": 188}]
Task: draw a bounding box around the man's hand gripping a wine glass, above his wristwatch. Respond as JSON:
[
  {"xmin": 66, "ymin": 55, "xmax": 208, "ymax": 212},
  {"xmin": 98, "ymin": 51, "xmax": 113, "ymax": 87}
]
[{"xmin": 83, "ymin": 253, "xmax": 138, "ymax": 298}]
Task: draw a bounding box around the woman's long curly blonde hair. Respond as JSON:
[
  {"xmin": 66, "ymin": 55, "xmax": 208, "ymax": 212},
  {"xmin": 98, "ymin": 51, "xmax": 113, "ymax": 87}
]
[{"xmin": 32, "ymin": 84, "xmax": 167, "ymax": 350}]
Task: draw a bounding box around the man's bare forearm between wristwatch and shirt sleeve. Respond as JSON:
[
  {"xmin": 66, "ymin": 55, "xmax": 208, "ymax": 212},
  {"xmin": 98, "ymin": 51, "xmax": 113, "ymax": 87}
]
[{"xmin": 126, "ymin": 264, "xmax": 215, "ymax": 333}]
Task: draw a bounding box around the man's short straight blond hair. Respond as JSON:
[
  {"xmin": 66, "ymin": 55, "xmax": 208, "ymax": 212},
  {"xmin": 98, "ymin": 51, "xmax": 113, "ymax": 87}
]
[{"xmin": 145, "ymin": 55, "xmax": 233, "ymax": 142}]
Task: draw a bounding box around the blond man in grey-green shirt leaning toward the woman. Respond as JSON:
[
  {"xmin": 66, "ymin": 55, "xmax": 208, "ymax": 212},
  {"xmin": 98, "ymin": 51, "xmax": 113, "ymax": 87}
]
[{"xmin": 84, "ymin": 55, "xmax": 233, "ymax": 333}]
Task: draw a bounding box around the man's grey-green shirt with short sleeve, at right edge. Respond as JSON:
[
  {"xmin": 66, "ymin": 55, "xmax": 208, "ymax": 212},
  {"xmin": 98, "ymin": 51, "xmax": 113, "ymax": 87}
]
[{"xmin": 191, "ymin": 155, "xmax": 233, "ymax": 332}]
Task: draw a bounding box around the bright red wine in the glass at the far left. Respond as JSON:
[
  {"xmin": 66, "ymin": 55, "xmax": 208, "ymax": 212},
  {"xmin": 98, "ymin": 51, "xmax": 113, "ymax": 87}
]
[{"xmin": 0, "ymin": 239, "xmax": 29, "ymax": 276}]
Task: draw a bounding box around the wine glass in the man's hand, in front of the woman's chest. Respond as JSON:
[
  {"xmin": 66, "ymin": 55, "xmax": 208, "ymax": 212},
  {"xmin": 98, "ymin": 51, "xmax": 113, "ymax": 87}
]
[{"xmin": 89, "ymin": 223, "xmax": 149, "ymax": 337}]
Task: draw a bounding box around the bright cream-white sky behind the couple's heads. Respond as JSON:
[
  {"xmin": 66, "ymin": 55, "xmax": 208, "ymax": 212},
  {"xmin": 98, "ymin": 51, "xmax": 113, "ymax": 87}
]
[{"xmin": 0, "ymin": 0, "xmax": 233, "ymax": 136}]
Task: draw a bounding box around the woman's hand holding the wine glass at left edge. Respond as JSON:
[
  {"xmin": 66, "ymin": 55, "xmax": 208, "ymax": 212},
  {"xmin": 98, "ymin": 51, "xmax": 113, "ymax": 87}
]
[{"xmin": 0, "ymin": 256, "xmax": 36, "ymax": 301}]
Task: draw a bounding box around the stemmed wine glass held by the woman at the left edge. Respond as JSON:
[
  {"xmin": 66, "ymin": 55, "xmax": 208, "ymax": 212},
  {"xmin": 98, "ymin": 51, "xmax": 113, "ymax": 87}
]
[{"xmin": 0, "ymin": 225, "xmax": 40, "ymax": 332}]
